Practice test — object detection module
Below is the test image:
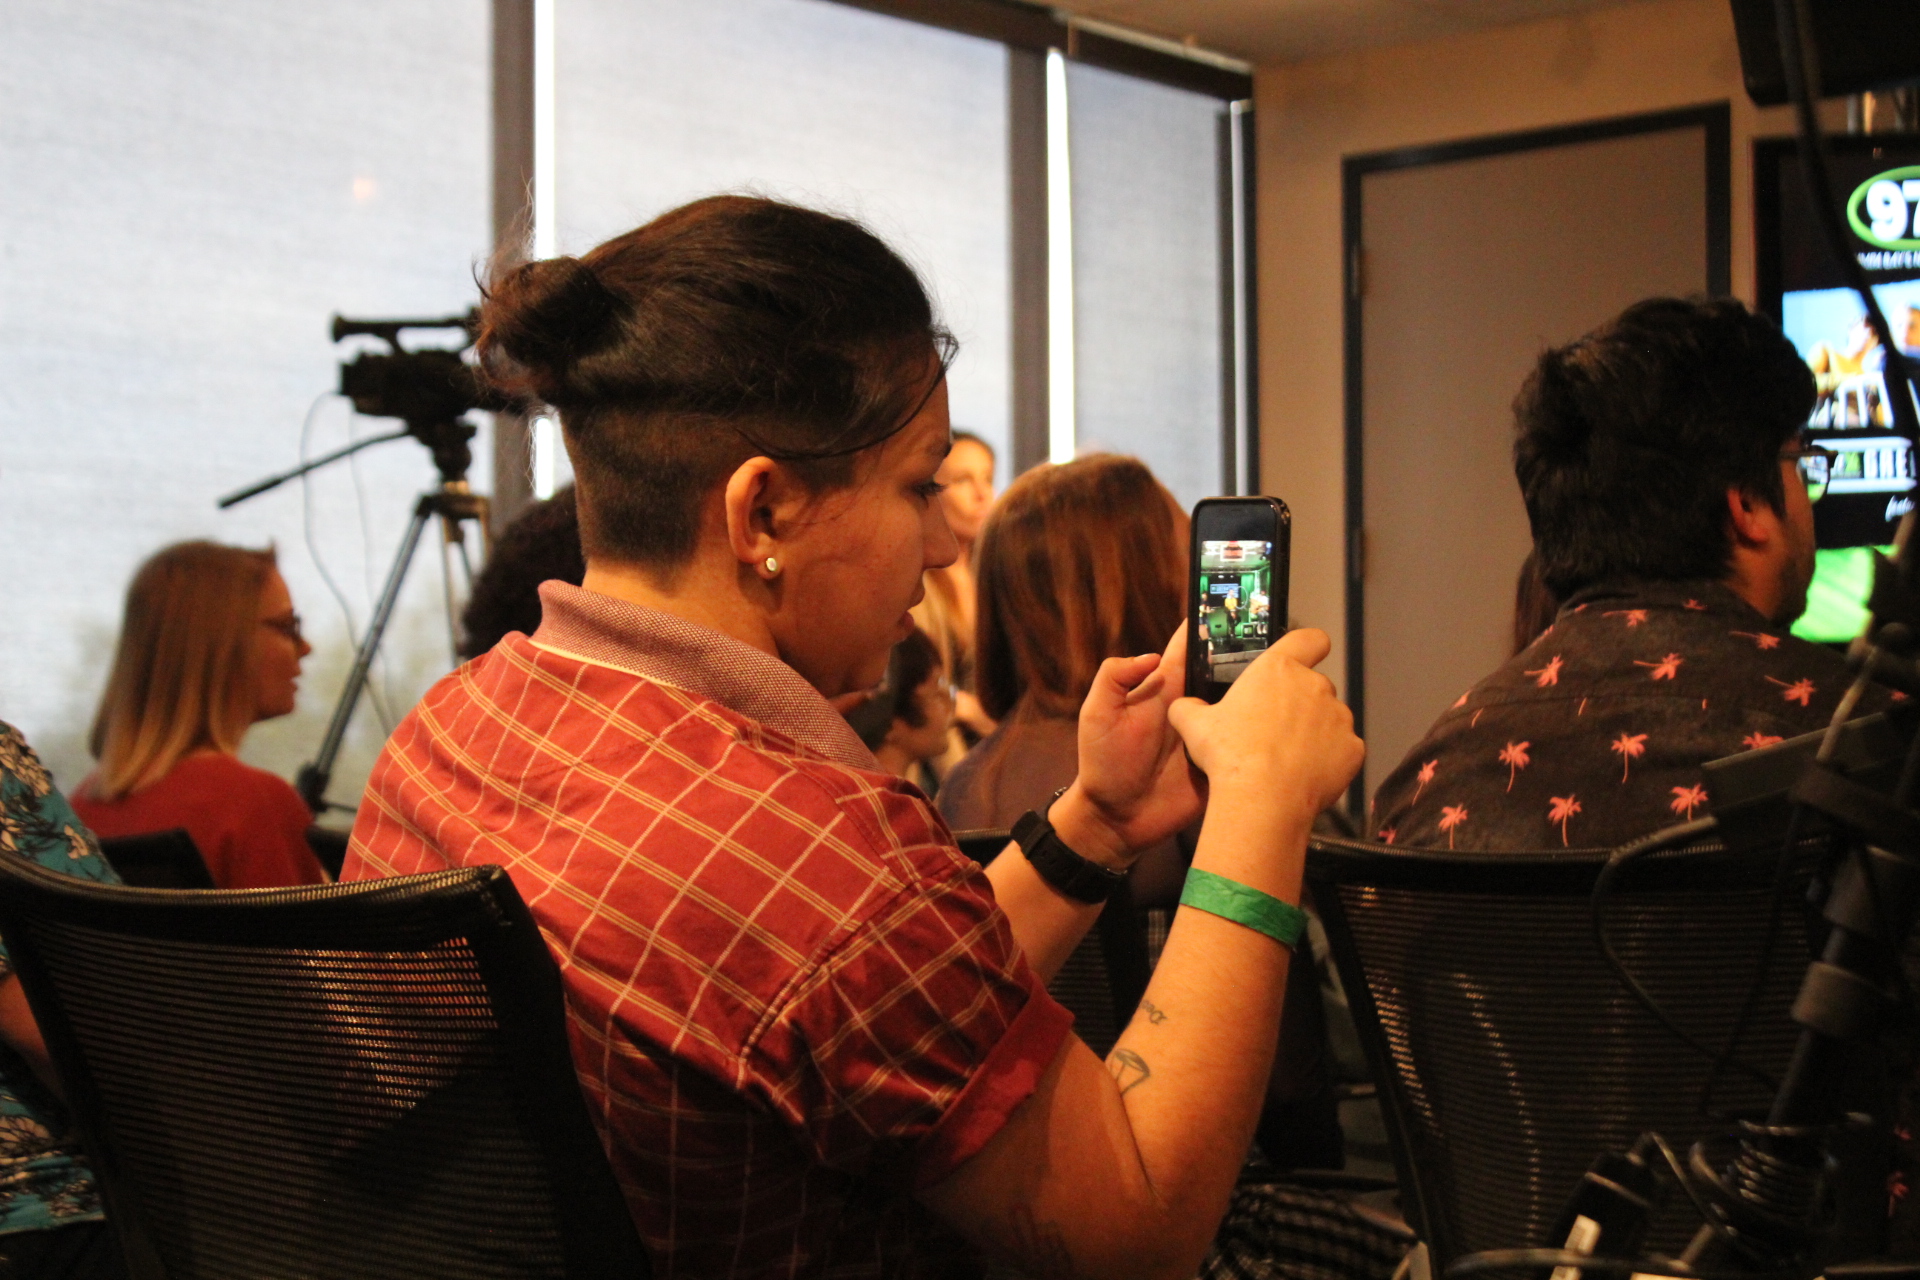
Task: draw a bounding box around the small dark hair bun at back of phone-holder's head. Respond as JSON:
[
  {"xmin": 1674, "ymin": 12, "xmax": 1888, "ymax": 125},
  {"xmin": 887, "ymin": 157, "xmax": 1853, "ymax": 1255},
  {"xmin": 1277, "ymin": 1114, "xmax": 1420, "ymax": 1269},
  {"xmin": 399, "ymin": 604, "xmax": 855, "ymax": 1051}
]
[{"xmin": 480, "ymin": 257, "xmax": 626, "ymax": 401}]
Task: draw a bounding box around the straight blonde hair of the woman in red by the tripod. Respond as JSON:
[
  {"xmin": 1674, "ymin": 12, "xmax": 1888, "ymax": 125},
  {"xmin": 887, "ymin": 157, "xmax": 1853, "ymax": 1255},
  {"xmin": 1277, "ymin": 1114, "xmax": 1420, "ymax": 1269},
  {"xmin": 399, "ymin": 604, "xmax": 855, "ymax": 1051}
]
[{"xmin": 88, "ymin": 541, "xmax": 275, "ymax": 800}]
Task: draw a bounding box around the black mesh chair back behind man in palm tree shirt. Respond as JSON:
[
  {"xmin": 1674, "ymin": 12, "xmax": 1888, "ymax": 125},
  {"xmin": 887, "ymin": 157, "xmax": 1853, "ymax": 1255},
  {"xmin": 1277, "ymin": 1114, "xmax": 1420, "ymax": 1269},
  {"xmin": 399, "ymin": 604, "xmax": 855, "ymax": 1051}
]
[{"xmin": 1308, "ymin": 839, "xmax": 1812, "ymax": 1267}]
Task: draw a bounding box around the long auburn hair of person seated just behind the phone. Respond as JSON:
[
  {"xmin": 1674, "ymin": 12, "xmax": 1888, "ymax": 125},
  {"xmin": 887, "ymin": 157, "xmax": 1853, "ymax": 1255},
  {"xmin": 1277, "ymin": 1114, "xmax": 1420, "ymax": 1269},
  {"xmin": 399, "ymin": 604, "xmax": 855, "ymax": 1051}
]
[{"xmin": 975, "ymin": 453, "xmax": 1187, "ymax": 720}]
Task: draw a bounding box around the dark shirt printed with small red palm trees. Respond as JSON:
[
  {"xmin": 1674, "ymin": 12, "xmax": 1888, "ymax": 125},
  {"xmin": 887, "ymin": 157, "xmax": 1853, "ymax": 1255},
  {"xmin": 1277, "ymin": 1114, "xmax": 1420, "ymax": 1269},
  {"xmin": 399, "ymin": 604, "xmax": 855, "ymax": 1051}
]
[{"xmin": 1371, "ymin": 581, "xmax": 1893, "ymax": 852}]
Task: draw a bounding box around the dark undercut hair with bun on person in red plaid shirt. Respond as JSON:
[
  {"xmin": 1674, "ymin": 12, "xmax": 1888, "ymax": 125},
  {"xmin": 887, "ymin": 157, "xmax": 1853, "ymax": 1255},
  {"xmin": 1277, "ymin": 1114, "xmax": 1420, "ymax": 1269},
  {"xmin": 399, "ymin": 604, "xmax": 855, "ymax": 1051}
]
[{"xmin": 480, "ymin": 196, "xmax": 954, "ymax": 570}]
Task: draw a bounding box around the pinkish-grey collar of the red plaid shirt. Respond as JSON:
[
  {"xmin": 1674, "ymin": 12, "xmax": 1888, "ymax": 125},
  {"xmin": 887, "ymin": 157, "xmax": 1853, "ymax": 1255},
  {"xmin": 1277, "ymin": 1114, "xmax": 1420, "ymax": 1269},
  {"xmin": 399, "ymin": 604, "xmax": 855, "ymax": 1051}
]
[{"xmin": 534, "ymin": 581, "xmax": 877, "ymax": 770}]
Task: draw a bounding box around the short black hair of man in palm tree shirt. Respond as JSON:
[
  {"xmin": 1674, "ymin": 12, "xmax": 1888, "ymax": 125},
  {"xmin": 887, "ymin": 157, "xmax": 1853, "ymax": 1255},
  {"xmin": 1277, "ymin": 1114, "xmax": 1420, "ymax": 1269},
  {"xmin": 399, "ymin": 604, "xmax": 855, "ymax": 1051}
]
[{"xmin": 1513, "ymin": 297, "xmax": 1814, "ymax": 599}]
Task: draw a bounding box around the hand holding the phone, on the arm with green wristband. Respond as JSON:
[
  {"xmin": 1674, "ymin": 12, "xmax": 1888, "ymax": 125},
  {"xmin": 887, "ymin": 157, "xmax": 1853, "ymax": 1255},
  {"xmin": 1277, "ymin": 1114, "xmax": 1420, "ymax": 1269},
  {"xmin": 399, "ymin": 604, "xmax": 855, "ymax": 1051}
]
[{"xmin": 1167, "ymin": 628, "xmax": 1367, "ymax": 819}]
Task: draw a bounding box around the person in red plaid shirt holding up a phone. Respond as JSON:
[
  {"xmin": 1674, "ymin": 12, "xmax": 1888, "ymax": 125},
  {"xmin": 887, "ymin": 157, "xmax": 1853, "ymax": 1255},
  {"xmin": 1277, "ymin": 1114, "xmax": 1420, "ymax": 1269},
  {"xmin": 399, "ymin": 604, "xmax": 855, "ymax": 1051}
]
[{"xmin": 346, "ymin": 196, "xmax": 1361, "ymax": 1278}]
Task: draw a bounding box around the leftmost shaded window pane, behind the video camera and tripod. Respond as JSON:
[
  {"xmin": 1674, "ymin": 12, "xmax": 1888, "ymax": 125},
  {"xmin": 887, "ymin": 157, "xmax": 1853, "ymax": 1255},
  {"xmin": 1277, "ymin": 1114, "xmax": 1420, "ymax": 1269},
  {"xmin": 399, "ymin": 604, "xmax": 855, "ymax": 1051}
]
[{"xmin": 0, "ymin": 0, "xmax": 490, "ymax": 800}]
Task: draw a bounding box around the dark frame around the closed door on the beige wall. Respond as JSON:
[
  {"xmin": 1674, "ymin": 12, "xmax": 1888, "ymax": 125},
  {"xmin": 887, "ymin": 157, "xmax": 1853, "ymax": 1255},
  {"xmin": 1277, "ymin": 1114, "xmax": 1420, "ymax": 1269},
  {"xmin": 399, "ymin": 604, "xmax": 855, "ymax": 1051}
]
[{"xmin": 1340, "ymin": 100, "xmax": 1734, "ymax": 821}]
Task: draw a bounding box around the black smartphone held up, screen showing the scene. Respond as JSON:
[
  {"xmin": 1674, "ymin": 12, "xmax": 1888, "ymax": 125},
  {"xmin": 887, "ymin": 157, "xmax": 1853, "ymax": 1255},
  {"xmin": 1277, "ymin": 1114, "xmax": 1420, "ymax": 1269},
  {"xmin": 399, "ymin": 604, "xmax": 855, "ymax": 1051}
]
[{"xmin": 1187, "ymin": 497, "xmax": 1294, "ymax": 702}]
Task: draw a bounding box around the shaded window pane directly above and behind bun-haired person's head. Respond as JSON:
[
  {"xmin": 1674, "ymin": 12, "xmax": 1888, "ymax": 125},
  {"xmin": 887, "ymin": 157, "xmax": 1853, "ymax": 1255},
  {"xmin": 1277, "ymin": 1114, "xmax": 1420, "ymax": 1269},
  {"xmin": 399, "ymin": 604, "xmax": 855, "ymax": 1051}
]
[{"xmin": 555, "ymin": 0, "xmax": 1010, "ymax": 478}]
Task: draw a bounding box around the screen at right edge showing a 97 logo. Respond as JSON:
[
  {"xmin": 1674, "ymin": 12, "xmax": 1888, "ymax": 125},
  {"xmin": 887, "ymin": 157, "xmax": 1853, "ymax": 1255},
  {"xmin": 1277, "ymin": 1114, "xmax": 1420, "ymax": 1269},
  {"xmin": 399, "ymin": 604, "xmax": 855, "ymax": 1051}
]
[{"xmin": 1753, "ymin": 134, "xmax": 1920, "ymax": 643}]
